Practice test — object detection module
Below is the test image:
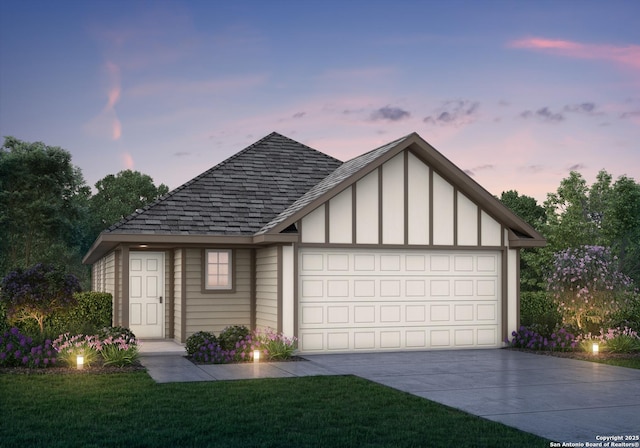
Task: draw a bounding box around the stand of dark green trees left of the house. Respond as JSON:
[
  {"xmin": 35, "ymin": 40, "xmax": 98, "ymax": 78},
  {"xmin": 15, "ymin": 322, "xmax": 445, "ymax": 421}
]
[{"xmin": 0, "ymin": 137, "xmax": 169, "ymax": 289}]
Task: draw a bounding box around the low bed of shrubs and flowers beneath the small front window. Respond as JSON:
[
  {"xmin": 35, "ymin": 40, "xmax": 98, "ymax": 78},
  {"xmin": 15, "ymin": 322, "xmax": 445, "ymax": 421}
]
[{"xmin": 186, "ymin": 326, "xmax": 296, "ymax": 364}]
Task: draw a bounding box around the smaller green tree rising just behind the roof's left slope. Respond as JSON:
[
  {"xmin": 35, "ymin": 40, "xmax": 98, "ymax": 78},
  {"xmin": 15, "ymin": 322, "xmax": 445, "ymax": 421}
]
[{"xmin": 91, "ymin": 170, "xmax": 169, "ymax": 233}]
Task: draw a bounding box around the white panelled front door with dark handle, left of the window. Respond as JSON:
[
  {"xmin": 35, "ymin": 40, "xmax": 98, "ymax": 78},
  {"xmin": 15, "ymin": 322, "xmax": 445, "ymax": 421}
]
[{"xmin": 129, "ymin": 252, "xmax": 164, "ymax": 338}]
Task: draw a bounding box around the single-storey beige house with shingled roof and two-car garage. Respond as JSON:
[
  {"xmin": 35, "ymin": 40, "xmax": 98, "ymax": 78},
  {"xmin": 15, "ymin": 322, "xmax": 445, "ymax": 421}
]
[{"xmin": 84, "ymin": 133, "xmax": 545, "ymax": 353}]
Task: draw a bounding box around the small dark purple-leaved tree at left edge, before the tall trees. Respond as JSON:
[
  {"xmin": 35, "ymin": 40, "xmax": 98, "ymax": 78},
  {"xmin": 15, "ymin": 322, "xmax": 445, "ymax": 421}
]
[{"xmin": 0, "ymin": 263, "xmax": 80, "ymax": 334}]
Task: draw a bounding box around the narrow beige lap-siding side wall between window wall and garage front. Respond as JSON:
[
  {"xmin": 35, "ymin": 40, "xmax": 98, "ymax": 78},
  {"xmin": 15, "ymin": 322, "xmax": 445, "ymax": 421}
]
[{"xmin": 256, "ymin": 245, "xmax": 278, "ymax": 329}]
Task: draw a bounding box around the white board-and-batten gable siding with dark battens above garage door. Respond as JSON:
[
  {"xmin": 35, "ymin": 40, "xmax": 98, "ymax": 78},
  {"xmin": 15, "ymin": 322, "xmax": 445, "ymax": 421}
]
[{"xmin": 301, "ymin": 151, "xmax": 503, "ymax": 248}]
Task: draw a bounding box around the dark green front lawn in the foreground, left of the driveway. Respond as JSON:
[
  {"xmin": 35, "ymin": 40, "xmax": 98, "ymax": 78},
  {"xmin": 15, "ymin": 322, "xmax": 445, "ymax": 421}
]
[{"xmin": 0, "ymin": 372, "xmax": 549, "ymax": 448}]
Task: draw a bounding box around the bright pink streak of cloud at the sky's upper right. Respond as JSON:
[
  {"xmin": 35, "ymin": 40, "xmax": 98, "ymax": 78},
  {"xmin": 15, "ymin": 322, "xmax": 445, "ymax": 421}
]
[{"xmin": 509, "ymin": 37, "xmax": 640, "ymax": 70}]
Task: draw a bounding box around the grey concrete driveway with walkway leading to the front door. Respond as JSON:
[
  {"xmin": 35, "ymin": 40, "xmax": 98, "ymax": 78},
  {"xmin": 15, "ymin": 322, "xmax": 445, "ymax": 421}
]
[{"xmin": 141, "ymin": 342, "xmax": 640, "ymax": 446}]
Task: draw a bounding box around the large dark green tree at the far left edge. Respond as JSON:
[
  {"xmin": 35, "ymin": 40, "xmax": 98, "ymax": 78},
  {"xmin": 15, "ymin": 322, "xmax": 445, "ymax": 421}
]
[{"xmin": 0, "ymin": 137, "xmax": 91, "ymax": 275}]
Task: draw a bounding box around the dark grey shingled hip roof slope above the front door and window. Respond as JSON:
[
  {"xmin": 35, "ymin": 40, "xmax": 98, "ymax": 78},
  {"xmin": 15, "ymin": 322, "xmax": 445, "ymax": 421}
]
[{"xmin": 103, "ymin": 132, "xmax": 342, "ymax": 235}]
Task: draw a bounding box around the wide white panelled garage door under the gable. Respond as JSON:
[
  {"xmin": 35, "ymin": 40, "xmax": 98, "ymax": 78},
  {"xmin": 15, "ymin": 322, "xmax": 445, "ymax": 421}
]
[{"xmin": 298, "ymin": 248, "xmax": 501, "ymax": 353}]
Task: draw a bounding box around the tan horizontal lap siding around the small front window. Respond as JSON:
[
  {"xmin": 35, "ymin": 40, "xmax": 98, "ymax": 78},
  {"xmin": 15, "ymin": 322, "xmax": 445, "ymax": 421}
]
[{"xmin": 182, "ymin": 249, "xmax": 251, "ymax": 337}]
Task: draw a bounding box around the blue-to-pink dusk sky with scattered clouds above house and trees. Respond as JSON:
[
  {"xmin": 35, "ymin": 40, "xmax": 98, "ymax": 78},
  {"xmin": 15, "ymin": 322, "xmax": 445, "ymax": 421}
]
[{"xmin": 0, "ymin": 0, "xmax": 640, "ymax": 203}]
